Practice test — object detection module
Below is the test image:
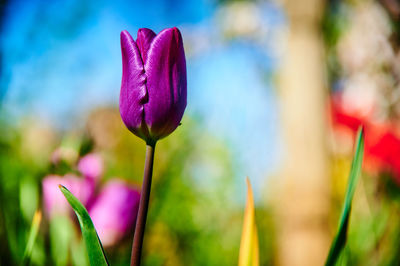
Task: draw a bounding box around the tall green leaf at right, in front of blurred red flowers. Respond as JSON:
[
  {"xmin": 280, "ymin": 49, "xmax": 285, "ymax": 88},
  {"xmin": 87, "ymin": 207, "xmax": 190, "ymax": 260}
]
[{"xmin": 325, "ymin": 127, "xmax": 364, "ymax": 266}]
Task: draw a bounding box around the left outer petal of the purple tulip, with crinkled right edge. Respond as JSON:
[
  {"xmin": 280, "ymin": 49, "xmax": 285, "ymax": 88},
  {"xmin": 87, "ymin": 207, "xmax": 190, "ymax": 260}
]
[{"xmin": 119, "ymin": 31, "xmax": 148, "ymax": 138}]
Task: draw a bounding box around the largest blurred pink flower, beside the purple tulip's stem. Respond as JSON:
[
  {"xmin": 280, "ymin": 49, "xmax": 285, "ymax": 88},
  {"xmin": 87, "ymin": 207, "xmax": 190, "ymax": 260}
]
[{"xmin": 89, "ymin": 179, "xmax": 140, "ymax": 246}]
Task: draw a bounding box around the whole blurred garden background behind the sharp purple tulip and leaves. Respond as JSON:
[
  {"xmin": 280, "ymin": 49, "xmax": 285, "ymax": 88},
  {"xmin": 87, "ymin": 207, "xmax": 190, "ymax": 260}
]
[{"xmin": 0, "ymin": 0, "xmax": 400, "ymax": 266}]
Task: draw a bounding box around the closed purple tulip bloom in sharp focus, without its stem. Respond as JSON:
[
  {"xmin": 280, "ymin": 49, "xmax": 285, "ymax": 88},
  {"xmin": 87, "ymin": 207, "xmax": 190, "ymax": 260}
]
[{"xmin": 119, "ymin": 28, "xmax": 187, "ymax": 143}]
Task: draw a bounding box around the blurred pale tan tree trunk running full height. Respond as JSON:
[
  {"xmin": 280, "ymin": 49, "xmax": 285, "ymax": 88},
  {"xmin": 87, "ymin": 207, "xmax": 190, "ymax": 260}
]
[{"xmin": 277, "ymin": 0, "xmax": 330, "ymax": 266}]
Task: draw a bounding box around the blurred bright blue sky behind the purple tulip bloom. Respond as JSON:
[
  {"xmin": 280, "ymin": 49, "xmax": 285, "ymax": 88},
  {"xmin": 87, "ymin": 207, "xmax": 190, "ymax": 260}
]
[{"xmin": 0, "ymin": 0, "xmax": 283, "ymax": 195}]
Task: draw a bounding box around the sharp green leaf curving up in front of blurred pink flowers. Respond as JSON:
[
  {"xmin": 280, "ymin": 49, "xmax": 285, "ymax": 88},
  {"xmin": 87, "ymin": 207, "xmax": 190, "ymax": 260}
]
[{"xmin": 59, "ymin": 185, "xmax": 109, "ymax": 266}]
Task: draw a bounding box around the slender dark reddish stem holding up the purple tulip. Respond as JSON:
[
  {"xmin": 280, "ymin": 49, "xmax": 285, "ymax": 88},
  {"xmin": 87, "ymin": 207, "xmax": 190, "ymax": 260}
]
[{"xmin": 131, "ymin": 143, "xmax": 156, "ymax": 266}]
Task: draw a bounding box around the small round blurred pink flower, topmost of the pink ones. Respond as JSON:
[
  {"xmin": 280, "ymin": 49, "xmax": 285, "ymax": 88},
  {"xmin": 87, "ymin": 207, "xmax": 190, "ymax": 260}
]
[{"xmin": 78, "ymin": 153, "xmax": 104, "ymax": 181}]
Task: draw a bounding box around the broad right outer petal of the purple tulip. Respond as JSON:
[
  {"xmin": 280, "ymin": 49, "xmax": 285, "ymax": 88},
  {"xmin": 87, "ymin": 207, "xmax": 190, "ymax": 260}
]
[{"xmin": 144, "ymin": 28, "xmax": 187, "ymax": 140}]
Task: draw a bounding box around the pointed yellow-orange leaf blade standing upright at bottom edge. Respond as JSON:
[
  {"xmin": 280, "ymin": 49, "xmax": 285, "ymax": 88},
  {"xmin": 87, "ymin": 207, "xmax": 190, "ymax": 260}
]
[{"xmin": 239, "ymin": 178, "xmax": 260, "ymax": 266}]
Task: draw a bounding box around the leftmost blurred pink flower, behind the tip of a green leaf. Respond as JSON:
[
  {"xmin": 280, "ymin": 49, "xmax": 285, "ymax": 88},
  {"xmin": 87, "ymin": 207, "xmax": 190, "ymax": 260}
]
[{"xmin": 42, "ymin": 174, "xmax": 94, "ymax": 218}]
